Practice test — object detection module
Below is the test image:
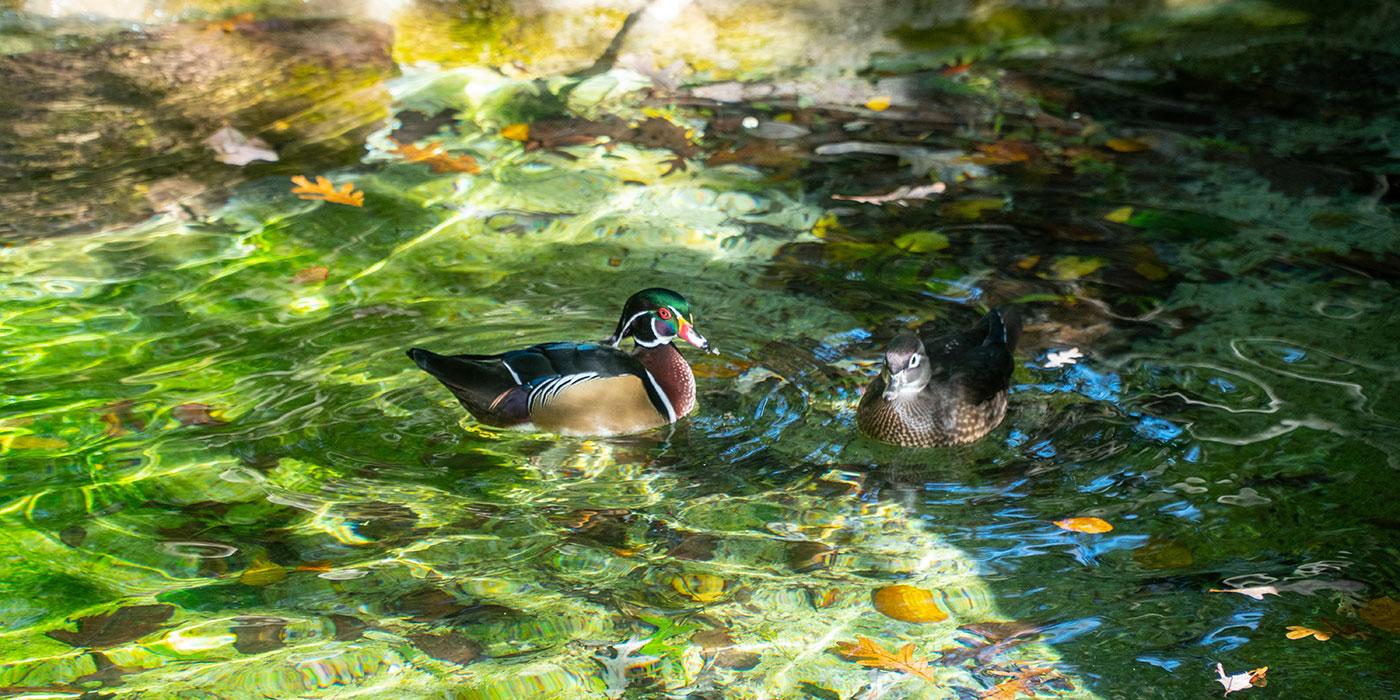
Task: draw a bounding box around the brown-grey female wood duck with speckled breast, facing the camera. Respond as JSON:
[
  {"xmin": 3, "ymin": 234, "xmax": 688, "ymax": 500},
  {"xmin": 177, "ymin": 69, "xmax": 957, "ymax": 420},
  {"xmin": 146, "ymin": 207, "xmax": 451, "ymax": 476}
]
[{"xmin": 855, "ymin": 311, "xmax": 1021, "ymax": 447}]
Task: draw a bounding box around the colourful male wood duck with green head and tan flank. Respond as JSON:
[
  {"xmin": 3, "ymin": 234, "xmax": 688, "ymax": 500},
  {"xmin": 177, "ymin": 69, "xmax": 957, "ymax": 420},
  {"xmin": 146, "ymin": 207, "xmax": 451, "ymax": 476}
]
[{"xmin": 409, "ymin": 287, "xmax": 710, "ymax": 435}]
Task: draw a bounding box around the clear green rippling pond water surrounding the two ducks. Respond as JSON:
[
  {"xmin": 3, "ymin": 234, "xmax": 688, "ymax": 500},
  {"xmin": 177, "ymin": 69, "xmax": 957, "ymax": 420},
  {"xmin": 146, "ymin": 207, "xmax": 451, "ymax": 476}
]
[{"xmin": 0, "ymin": 3, "xmax": 1400, "ymax": 699}]
